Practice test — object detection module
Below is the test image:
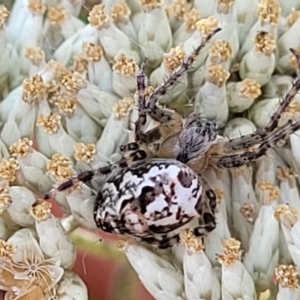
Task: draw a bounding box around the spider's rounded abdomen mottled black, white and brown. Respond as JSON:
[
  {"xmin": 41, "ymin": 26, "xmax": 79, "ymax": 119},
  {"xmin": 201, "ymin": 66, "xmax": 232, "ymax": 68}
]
[{"xmin": 94, "ymin": 159, "xmax": 203, "ymax": 246}]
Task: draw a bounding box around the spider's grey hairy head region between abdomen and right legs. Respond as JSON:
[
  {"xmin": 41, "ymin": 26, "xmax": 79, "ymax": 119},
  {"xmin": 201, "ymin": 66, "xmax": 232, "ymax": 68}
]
[{"xmin": 176, "ymin": 119, "xmax": 218, "ymax": 163}]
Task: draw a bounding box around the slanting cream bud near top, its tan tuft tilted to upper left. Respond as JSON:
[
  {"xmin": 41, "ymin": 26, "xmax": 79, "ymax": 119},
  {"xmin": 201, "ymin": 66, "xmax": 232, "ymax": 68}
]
[{"xmin": 88, "ymin": 4, "xmax": 140, "ymax": 63}]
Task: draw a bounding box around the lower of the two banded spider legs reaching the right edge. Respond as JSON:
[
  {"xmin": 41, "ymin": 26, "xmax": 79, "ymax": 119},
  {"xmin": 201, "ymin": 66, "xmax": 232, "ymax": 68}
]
[{"xmin": 210, "ymin": 120, "xmax": 300, "ymax": 168}]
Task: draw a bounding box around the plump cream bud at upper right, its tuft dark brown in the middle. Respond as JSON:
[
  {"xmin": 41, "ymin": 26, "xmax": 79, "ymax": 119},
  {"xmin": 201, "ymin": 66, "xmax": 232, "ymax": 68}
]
[{"xmin": 239, "ymin": 32, "xmax": 275, "ymax": 85}]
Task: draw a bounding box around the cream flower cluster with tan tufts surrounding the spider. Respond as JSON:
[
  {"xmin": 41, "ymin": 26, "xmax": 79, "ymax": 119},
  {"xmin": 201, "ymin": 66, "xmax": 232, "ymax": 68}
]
[{"xmin": 0, "ymin": 0, "xmax": 300, "ymax": 300}]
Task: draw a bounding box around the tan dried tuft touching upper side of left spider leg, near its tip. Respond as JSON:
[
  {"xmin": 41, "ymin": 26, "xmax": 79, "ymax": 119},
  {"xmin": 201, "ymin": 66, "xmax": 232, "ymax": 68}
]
[{"xmin": 47, "ymin": 153, "xmax": 74, "ymax": 182}]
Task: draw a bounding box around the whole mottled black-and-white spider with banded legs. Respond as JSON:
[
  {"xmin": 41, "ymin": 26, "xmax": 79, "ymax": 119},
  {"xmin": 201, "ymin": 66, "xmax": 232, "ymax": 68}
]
[{"xmin": 45, "ymin": 30, "xmax": 300, "ymax": 248}]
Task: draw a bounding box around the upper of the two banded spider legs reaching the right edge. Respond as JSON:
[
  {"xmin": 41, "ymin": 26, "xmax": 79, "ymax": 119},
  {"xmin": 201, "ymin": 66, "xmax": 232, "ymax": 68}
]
[{"xmin": 223, "ymin": 49, "xmax": 300, "ymax": 152}]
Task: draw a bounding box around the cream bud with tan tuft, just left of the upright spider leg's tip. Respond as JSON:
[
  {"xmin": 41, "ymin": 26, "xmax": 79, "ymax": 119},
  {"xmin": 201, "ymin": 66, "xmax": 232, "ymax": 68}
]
[{"xmin": 112, "ymin": 54, "xmax": 139, "ymax": 97}]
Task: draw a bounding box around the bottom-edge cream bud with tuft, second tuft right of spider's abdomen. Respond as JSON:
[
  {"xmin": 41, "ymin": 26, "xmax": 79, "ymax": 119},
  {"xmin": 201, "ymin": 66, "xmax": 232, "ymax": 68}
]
[{"xmin": 217, "ymin": 239, "xmax": 256, "ymax": 300}]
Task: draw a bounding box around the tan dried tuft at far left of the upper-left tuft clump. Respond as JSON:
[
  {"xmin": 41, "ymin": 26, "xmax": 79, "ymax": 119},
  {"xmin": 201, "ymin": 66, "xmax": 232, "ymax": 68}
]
[{"xmin": 22, "ymin": 75, "xmax": 46, "ymax": 104}]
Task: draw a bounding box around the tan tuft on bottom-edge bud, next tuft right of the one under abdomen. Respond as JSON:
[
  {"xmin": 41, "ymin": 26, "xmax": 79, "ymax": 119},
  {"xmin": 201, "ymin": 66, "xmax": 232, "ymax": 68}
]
[{"xmin": 217, "ymin": 238, "xmax": 241, "ymax": 266}]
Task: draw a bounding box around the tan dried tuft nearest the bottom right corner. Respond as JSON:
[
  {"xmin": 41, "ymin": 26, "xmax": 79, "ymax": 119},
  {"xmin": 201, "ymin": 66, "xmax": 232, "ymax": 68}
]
[{"xmin": 275, "ymin": 265, "xmax": 299, "ymax": 289}]
